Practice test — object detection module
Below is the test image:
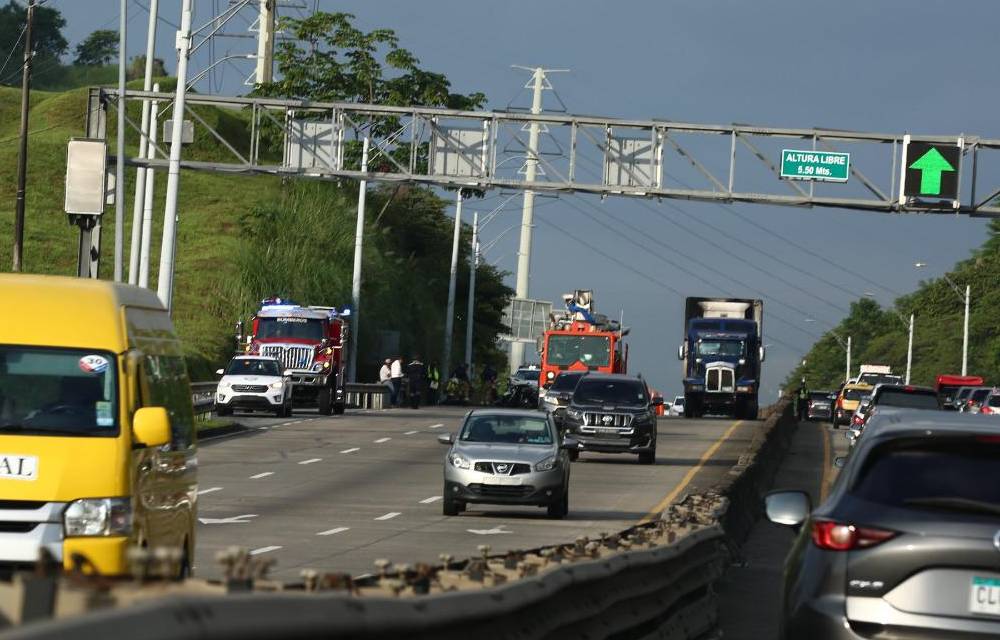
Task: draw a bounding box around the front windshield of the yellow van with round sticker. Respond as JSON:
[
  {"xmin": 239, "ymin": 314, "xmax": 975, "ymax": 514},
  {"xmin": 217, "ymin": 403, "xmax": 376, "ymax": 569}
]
[{"xmin": 0, "ymin": 346, "xmax": 118, "ymax": 436}]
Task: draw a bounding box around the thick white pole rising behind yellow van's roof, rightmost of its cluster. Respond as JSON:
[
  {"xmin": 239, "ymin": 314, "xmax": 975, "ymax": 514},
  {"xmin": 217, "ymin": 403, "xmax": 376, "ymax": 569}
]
[{"xmin": 157, "ymin": 0, "xmax": 193, "ymax": 311}]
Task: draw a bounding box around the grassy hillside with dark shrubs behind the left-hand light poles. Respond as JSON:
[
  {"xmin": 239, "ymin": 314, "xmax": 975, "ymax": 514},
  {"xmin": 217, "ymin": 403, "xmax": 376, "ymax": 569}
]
[{"xmin": 0, "ymin": 79, "xmax": 511, "ymax": 378}]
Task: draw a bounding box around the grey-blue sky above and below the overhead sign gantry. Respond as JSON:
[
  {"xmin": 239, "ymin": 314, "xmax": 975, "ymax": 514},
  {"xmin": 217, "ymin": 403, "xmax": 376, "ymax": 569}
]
[{"xmin": 58, "ymin": 0, "xmax": 1000, "ymax": 401}]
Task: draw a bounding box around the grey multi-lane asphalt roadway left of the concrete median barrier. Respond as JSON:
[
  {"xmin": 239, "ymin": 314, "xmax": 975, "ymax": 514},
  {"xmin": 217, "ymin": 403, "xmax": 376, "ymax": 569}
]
[{"xmin": 195, "ymin": 407, "xmax": 753, "ymax": 580}]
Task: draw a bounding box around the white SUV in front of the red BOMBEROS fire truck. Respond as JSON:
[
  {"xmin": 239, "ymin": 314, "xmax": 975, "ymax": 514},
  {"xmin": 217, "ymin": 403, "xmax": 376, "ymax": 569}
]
[{"xmin": 215, "ymin": 356, "xmax": 292, "ymax": 418}]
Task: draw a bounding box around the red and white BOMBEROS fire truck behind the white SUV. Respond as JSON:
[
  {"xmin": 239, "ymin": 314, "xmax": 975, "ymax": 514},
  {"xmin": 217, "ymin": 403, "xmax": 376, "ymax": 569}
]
[{"xmin": 237, "ymin": 298, "xmax": 350, "ymax": 415}]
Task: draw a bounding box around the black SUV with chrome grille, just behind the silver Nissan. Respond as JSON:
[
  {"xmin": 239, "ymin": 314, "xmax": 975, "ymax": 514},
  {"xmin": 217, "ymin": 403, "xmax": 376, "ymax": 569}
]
[{"xmin": 563, "ymin": 373, "xmax": 663, "ymax": 464}]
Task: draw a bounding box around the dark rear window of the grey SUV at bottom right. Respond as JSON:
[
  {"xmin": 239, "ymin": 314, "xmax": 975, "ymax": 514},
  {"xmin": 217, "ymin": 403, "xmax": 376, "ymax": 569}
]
[{"xmin": 851, "ymin": 438, "xmax": 1000, "ymax": 509}]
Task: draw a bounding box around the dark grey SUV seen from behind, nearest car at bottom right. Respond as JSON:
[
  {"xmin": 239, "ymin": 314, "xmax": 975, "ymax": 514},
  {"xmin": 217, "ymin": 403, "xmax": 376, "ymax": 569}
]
[{"xmin": 766, "ymin": 408, "xmax": 1000, "ymax": 640}]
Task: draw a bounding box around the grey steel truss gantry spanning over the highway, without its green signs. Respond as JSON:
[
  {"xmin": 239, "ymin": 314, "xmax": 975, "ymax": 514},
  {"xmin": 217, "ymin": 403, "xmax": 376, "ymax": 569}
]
[{"xmin": 94, "ymin": 88, "xmax": 1000, "ymax": 216}]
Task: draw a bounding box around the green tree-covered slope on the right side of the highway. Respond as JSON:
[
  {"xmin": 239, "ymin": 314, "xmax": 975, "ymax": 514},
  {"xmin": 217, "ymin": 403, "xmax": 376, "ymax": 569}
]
[{"xmin": 786, "ymin": 220, "xmax": 1000, "ymax": 389}]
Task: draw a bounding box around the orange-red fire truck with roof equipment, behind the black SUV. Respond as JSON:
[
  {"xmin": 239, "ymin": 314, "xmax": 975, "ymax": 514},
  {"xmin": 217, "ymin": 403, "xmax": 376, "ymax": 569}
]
[{"xmin": 538, "ymin": 290, "xmax": 628, "ymax": 388}]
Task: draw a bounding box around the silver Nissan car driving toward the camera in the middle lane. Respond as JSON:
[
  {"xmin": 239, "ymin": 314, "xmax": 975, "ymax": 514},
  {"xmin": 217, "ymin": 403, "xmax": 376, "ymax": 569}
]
[{"xmin": 438, "ymin": 409, "xmax": 577, "ymax": 518}]
